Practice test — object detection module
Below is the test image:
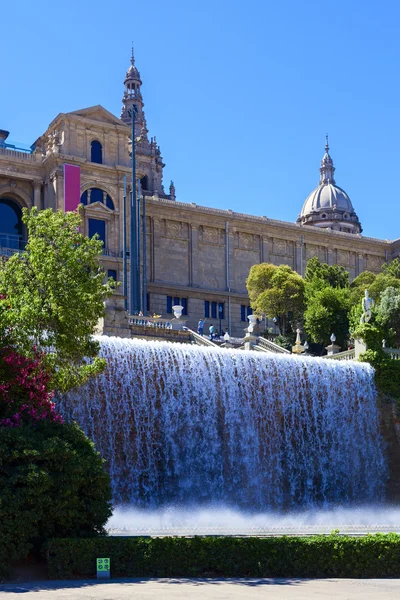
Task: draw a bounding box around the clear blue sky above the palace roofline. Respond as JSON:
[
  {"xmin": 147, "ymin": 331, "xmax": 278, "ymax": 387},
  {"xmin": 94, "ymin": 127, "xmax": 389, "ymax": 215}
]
[{"xmin": 0, "ymin": 0, "xmax": 400, "ymax": 239}]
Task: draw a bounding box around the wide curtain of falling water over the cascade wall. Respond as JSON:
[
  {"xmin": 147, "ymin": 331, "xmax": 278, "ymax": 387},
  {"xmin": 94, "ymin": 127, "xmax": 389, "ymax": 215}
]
[{"xmin": 58, "ymin": 337, "xmax": 387, "ymax": 510}]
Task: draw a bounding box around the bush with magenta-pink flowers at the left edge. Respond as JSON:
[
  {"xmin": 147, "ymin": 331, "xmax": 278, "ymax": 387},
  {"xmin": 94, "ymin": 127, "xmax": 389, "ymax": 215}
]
[{"xmin": 0, "ymin": 348, "xmax": 62, "ymax": 427}]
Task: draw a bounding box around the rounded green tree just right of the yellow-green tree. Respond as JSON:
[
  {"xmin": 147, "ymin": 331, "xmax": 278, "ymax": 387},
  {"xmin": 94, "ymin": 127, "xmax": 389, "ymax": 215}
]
[{"xmin": 304, "ymin": 286, "xmax": 351, "ymax": 348}]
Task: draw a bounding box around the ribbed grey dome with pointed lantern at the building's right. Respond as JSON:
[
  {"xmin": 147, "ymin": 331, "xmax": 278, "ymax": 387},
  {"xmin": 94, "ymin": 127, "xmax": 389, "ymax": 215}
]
[{"xmin": 297, "ymin": 136, "xmax": 362, "ymax": 233}]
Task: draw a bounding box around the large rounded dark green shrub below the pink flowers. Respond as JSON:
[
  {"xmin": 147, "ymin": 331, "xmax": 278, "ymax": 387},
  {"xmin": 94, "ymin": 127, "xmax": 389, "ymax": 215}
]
[{"xmin": 0, "ymin": 421, "xmax": 111, "ymax": 573}]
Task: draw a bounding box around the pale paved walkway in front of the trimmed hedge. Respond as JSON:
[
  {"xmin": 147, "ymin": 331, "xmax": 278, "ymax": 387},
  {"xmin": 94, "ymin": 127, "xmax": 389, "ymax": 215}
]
[{"xmin": 0, "ymin": 579, "xmax": 400, "ymax": 600}]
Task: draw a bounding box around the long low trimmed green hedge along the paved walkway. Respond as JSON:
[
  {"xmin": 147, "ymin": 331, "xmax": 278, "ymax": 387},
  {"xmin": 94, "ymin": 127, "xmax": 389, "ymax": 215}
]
[{"xmin": 47, "ymin": 533, "xmax": 400, "ymax": 579}]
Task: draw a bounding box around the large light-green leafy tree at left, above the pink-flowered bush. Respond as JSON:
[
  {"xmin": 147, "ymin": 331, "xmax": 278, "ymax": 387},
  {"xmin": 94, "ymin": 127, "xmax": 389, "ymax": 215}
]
[{"xmin": 0, "ymin": 208, "xmax": 115, "ymax": 390}]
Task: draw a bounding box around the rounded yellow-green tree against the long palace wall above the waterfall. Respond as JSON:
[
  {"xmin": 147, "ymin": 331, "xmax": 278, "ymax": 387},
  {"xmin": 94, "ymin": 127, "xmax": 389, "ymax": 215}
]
[{"xmin": 246, "ymin": 263, "xmax": 304, "ymax": 335}]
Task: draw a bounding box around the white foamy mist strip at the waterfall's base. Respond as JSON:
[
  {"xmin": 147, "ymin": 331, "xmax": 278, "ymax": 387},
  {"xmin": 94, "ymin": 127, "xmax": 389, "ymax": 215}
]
[{"xmin": 107, "ymin": 505, "xmax": 400, "ymax": 536}]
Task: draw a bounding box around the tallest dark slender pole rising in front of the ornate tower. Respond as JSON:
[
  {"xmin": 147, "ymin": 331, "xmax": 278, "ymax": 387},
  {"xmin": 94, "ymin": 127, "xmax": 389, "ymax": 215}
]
[{"xmin": 129, "ymin": 104, "xmax": 140, "ymax": 315}]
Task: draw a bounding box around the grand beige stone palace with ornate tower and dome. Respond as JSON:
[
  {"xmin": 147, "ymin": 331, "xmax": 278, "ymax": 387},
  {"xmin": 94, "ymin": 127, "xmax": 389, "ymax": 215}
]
[{"xmin": 0, "ymin": 55, "xmax": 400, "ymax": 335}]
